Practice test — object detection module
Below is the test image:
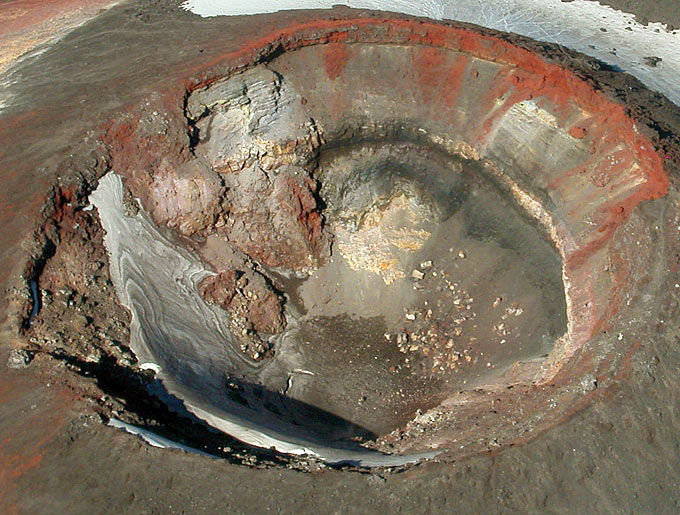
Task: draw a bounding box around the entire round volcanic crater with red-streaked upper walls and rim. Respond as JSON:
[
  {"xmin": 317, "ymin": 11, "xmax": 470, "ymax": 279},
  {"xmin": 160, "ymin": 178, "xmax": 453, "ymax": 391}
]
[{"xmin": 21, "ymin": 17, "xmax": 669, "ymax": 466}]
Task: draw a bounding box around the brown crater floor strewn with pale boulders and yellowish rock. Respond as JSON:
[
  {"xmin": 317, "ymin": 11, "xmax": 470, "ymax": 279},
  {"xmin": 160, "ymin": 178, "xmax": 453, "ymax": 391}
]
[{"xmin": 273, "ymin": 141, "xmax": 566, "ymax": 435}]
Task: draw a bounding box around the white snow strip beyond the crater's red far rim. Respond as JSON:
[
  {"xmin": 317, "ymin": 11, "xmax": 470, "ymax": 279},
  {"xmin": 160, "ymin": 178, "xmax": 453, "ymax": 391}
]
[{"xmin": 183, "ymin": 0, "xmax": 680, "ymax": 105}]
